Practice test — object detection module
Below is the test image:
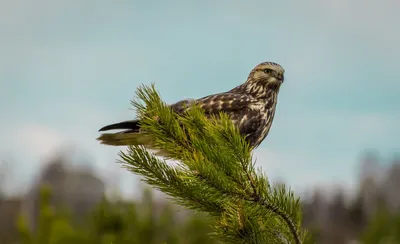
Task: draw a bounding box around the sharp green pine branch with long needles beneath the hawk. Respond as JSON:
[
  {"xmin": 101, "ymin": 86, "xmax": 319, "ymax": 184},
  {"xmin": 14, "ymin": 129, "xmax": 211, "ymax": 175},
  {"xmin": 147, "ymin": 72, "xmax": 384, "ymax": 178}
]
[{"xmin": 120, "ymin": 86, "xmax": 306, "ymax": 243}]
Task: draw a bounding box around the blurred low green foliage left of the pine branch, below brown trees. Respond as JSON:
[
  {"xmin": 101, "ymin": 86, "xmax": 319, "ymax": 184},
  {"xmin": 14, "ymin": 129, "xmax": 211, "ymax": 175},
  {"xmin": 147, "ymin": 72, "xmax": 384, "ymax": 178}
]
[{"xmin": 17, "ymin": 187, "xmax": 215, "ymax": 244}]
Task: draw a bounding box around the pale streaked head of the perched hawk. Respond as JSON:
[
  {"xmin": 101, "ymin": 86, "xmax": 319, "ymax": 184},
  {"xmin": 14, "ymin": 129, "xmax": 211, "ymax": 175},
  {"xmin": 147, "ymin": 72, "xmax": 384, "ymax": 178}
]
[{"xmin": 247, "ymin": 62, "xmax": 285, "ymax": 88}]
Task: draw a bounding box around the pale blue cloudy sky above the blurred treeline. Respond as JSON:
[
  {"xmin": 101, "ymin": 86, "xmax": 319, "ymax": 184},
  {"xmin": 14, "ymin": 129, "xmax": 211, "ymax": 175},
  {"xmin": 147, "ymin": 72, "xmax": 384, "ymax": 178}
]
[{"xmin": 0, "ymin": 0, "xmax": 400, "ymax": 198}]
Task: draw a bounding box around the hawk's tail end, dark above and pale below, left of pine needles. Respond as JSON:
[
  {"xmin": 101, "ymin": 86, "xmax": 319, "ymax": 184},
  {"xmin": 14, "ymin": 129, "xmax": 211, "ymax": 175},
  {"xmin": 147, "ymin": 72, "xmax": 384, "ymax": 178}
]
[{"xmin": 97, "ymin": 120, "xmax": 153, "ymax": 146}]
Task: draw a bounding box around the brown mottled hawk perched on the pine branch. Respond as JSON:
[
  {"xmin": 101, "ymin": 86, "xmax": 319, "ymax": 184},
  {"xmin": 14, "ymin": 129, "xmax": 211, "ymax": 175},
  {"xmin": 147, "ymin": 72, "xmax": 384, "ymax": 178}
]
[{"xmin": 98, "ymin": 62, "xmax": 285, "ymax": 152}]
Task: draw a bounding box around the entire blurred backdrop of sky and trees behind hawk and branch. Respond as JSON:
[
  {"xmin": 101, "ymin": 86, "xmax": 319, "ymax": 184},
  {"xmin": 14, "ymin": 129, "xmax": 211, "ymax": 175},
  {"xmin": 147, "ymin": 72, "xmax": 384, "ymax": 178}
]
[{"xmin": 0, "ymin": 0, "xmax": 400, "ymax": 244}]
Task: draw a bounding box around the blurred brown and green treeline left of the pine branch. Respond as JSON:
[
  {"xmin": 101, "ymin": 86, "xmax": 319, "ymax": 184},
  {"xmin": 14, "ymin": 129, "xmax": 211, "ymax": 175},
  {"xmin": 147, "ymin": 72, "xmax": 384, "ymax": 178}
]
[{"xmin": 0, "ymin": 157, "xmax": 215, "ymax": 244}]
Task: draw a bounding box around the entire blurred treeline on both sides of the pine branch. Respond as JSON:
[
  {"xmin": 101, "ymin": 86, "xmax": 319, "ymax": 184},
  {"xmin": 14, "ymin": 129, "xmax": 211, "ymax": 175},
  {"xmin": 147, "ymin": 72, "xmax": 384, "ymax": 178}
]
[{"xmin": 0, "ymin": 152, "xmax": 400, "ymax": 244}]
